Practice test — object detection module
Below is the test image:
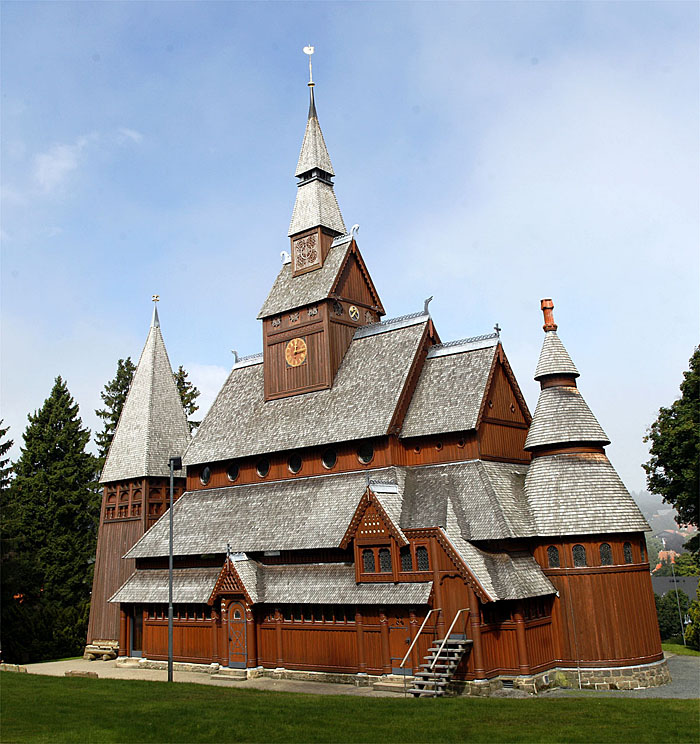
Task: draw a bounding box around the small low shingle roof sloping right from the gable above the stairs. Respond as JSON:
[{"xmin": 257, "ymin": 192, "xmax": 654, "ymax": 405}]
[{"xmin": 447, "ymin": 534, "xmax": 556, "ymax": 601}]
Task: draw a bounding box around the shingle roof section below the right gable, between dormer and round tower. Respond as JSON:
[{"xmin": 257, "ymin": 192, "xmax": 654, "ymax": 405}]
[{"xmin": 400, "ymin": 460, "xmax": 534, "ymax": 540}]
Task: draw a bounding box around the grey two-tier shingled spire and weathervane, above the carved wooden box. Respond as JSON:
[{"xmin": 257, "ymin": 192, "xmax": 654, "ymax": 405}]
[{"xmin": 289, "ymin": 46, "xmax": 345, "ymax": 237}]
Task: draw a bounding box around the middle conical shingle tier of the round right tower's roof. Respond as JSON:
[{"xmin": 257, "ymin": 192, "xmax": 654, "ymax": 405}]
[{"xmin": 525, "ymin": 386, "xmax": 610, "ymax": 449}]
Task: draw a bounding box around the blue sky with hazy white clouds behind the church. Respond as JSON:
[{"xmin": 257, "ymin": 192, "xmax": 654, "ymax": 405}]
[{"xmin": 0, "ymin": 0, "xmax": 700, "ymax": 490}]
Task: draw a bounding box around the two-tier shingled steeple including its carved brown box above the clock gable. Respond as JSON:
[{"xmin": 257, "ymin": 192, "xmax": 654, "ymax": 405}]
[{"xmin": 289, "ymin": 52, "xmax": 345, "ymax": 251}]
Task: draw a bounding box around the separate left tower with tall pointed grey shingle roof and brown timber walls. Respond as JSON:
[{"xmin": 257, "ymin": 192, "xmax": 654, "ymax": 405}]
[{"xmin": 87, "ymin": 306, "xmax": 190, "ymax": 650}]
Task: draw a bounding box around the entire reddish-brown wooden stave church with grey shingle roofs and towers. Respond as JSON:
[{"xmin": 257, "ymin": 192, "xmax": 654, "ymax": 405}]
[{"xmin": 88, "ymin": 71, "xmax": 668, "ymax": 695}]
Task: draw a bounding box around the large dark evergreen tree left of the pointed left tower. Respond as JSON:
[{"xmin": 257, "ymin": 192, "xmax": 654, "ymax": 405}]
[{"xmin": 1, "ymin": 377, "xmax": 100, "ymax": 662}]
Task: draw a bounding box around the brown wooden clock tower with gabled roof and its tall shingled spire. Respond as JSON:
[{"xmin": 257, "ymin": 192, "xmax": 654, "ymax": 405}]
[{"xmin": 258, "ymin": 82, "xmax": 384, "ymax": 400}]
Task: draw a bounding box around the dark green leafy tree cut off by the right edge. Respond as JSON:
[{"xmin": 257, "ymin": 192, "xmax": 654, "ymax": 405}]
[{"xmin": 642, "ymin": 347, "xmax": 700, "ymax": 532}]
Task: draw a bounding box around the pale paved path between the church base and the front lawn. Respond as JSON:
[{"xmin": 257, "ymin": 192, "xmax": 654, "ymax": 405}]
[{"xmin": 21, "ymin": 655, "xmax": 700, "ymax": 699}]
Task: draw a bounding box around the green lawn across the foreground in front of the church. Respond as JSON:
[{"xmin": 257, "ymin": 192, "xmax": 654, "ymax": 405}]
[{"xmin": 0, "ymin": 672, "xmax": 700, "ymax": 744}]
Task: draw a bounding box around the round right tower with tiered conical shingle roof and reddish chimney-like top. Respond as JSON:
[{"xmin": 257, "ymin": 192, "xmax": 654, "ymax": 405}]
[{"xmin": 525, "ymin": 299, "xmax": 668, "ymax": 687}]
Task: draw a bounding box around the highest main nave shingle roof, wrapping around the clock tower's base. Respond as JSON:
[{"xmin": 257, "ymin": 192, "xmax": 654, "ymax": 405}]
[{"xmin": 183, "ymin": 317, "xmax": 427, "ymax": 465}]
